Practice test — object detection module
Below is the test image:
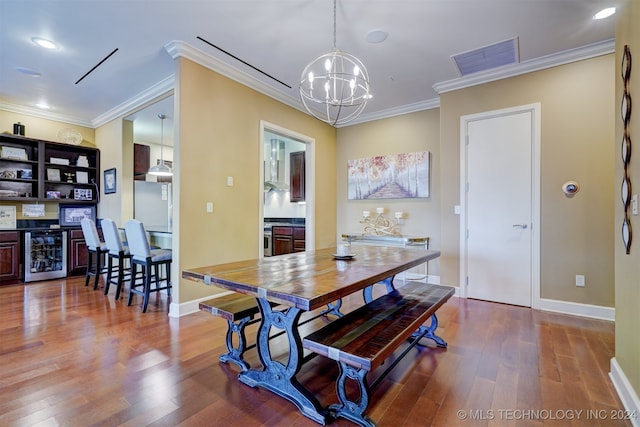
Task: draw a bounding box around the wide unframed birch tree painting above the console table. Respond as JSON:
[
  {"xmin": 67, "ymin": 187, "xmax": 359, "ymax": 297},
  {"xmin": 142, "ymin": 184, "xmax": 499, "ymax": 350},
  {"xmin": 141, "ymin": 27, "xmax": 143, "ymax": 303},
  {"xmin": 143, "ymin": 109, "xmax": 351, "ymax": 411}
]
[{"xmin": 347, "ymin": 151, "xmax": 430, "ymax": 200}]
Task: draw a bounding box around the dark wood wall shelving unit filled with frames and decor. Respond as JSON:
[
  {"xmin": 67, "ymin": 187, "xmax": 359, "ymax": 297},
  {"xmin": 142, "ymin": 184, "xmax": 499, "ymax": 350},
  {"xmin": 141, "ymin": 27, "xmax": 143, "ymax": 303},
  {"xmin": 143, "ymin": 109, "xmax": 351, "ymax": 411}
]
[{"xmin": 0, "ymin": 134, "xmax": 100, "ymax": 204}]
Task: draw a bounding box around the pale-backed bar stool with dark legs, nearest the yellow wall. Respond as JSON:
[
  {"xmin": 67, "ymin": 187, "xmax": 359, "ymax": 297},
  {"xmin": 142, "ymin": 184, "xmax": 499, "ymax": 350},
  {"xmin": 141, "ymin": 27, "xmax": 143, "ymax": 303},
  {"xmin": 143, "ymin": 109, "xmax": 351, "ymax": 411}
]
[{"xmin": 124, "ymin": 219, "xmax": 172, "ymax": 313}]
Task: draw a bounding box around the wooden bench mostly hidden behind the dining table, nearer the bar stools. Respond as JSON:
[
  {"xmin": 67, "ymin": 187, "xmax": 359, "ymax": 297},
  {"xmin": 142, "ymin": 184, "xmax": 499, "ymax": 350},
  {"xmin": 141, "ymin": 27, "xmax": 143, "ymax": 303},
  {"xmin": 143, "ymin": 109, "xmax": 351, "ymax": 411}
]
[{"xmin": 199, "ymin": 293, "xmax": 343, "ymax": 371}]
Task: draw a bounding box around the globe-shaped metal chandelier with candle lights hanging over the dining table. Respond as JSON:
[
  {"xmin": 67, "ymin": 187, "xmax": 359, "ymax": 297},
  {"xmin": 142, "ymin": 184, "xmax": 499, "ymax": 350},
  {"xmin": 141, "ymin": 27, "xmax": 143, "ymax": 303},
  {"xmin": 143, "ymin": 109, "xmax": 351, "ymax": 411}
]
[{"xmin": 300, "ymin": 0, "xmax": 371, "ymax": 126}]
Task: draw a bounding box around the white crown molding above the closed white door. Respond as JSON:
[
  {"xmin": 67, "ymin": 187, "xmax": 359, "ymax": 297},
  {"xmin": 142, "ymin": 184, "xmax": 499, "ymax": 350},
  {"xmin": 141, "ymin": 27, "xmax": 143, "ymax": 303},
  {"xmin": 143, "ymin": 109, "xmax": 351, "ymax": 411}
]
[{"xmin": 433, "ymin": 39, "xmax": 615, "ymax": 94}]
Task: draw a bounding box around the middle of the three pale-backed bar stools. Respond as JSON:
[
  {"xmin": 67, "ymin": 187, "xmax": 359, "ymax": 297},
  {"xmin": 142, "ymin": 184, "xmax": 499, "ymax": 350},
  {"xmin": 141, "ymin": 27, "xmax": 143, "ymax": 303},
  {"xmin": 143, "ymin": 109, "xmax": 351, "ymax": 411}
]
[{"xmin": 101, "ymin": 218, "xmax": 131, "ymax": 299}]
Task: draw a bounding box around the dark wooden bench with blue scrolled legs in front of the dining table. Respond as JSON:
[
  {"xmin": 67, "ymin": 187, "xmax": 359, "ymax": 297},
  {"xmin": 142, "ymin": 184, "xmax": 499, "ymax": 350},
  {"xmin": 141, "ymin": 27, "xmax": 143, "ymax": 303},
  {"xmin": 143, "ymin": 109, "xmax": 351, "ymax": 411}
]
[{"xmin": 303, "ymin": 282, "xmax": 454, "ymax": 426}]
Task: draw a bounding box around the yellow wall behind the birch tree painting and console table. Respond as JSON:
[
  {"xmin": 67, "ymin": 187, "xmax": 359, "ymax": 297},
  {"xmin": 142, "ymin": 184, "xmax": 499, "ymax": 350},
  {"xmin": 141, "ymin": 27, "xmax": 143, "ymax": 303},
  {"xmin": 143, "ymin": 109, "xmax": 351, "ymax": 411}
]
[{"xmin": 336, "ymin": 108, "xmax": 441, "ymax": 275}]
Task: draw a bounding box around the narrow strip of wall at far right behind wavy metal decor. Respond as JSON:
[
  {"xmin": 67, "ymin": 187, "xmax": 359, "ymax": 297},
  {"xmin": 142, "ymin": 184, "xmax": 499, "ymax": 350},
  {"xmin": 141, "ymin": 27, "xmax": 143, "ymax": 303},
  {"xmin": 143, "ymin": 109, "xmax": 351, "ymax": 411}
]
[{"xmin": 613, "ymin": 1, "xmax": 640, "ymax": 398}]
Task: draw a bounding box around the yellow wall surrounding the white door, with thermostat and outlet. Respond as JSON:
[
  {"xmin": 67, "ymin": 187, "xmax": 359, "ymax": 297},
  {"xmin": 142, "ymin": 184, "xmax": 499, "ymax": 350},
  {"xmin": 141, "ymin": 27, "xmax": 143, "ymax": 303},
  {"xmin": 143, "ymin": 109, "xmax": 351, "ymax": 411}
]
[{"xmin": 440, "ymin": 54, "xmax": 618, "ymax": 307}]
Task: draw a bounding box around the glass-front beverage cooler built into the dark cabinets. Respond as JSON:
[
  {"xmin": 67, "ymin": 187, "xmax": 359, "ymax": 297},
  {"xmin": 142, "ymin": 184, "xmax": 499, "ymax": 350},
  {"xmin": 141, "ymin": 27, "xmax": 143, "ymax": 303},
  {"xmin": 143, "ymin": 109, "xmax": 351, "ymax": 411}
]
[{"xmin": 24, "ymin": 230, "xmax": 67, "ymax": 282}]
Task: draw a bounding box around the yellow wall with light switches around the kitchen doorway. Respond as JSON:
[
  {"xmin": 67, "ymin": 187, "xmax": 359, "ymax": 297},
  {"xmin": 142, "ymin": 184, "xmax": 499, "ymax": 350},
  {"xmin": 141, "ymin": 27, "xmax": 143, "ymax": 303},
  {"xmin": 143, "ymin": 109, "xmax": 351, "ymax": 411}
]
[{"xmin": 174, "ymin": 59, "xmax": 337, "ymax": 302}]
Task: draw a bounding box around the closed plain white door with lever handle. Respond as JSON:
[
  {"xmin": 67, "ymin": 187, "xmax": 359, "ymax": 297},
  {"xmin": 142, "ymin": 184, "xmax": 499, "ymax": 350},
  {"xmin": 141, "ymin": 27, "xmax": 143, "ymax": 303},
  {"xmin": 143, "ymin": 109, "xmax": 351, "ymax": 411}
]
[{"xmin": 463, "ymin": 109, "xmax": 536, "ymax": 307}]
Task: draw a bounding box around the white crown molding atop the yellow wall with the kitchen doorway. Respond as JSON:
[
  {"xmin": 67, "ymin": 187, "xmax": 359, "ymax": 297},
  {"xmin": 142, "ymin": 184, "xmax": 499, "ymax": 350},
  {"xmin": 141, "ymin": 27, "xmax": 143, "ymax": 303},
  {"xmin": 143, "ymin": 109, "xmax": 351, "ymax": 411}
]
[{"xmin": 164, "ymin": 40, "xmax": 305, "ymax": 112}]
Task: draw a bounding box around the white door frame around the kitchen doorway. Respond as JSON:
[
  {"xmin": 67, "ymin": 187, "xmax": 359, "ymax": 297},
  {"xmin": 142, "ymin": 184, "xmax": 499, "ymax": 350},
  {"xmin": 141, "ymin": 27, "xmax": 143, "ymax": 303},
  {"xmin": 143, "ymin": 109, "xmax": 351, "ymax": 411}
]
[{"xmin": 258, "ymin": 120, "xmax": 316, "ymax": 258}]
